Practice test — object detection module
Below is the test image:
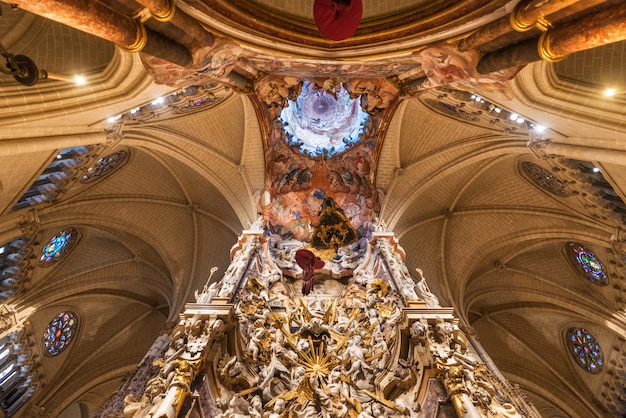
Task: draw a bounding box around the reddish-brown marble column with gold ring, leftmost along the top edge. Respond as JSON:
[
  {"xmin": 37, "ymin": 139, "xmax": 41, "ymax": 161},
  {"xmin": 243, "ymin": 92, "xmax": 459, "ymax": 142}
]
[{"xmin": 13, "ymin": 0, "xmax": 192, "ymax": 67}]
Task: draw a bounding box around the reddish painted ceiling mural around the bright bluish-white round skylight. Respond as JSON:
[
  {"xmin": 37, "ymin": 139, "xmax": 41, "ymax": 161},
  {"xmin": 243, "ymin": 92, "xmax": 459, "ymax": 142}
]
[{"xmin": 256, "ymin": 77, "xmax": 397, "ymax": 243}]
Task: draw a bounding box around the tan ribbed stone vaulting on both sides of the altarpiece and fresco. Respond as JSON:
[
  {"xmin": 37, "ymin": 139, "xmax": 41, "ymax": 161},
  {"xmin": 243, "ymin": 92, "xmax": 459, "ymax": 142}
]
[{"xmin": 0, "ymin": 1, "xmax": 626, "ymax": 417}]
